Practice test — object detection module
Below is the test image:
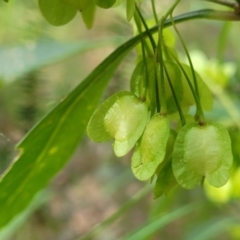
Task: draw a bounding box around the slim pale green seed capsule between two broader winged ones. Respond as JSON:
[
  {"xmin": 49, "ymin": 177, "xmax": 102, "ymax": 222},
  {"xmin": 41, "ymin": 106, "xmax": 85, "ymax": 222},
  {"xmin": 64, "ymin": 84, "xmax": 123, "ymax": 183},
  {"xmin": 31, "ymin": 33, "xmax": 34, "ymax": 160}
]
[{"xmin": 132, "ymin": 113, "xmax": 170, "ymax": 180}]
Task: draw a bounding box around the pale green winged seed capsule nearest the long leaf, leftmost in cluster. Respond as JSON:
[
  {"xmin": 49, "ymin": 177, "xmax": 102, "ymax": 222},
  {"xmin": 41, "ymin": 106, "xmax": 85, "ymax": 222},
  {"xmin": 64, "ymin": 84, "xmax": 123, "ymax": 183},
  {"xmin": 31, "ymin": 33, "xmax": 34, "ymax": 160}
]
[{"xmin": 87, "ymin": 92, "xmax": 148, "ymax": 157}]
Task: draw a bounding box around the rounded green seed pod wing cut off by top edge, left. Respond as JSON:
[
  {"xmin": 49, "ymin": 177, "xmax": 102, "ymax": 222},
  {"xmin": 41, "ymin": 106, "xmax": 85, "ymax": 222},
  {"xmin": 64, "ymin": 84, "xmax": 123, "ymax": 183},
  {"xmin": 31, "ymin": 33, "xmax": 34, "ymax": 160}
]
[{"xmin": 38, "ymin": 0, "xmax": 77, "ymax": 26}]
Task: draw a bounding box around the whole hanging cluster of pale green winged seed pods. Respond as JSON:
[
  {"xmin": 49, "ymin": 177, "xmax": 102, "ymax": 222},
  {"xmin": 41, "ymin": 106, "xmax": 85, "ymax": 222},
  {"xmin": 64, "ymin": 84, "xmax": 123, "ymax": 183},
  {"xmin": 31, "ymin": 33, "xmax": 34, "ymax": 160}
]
[{"xmin": 87, "ymin": 54, "xmax": 232, "ymax": 197}]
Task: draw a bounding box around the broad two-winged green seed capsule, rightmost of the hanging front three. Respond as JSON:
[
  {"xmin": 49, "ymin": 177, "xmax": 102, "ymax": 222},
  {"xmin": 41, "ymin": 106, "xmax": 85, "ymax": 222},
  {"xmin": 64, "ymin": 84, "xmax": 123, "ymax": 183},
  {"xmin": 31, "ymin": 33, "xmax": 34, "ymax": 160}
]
[{"xmin": 172, "ymin": 123, "xmax": 232, "ymax": 189}]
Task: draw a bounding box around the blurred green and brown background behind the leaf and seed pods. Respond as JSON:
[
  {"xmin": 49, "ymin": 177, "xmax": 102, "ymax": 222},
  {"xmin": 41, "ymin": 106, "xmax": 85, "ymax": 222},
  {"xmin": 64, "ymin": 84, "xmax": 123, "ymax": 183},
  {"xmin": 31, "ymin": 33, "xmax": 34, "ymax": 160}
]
[{"xmin": 0, "ymin": 0, "xmax": 240, "ymax": 240}]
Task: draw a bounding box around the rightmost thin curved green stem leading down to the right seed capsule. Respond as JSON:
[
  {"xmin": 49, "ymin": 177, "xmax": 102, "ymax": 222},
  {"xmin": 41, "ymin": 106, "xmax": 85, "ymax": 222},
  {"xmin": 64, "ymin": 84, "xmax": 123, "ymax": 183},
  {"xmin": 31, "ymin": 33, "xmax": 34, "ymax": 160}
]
[{"xmin": 170, "ymin": 13, "xmax": 205, "ymax": 122}]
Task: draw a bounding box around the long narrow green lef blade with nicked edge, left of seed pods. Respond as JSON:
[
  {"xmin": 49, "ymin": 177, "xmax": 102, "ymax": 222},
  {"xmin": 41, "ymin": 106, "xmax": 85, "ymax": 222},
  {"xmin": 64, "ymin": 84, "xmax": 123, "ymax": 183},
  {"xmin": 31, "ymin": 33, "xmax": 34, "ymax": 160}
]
[{"xmin": 0, "ymin": 35, "xmax": 132, "ymax": 228}]
